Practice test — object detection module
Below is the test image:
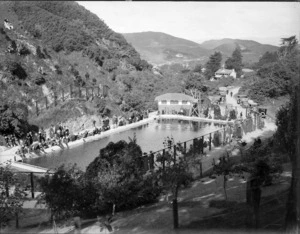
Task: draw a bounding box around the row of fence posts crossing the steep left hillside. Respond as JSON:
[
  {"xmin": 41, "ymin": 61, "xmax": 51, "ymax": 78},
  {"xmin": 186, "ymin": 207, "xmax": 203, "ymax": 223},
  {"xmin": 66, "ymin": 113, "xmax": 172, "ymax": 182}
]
[{"xmin": 34, "ymin": 85, "xmax": 108, "ymax": 116}]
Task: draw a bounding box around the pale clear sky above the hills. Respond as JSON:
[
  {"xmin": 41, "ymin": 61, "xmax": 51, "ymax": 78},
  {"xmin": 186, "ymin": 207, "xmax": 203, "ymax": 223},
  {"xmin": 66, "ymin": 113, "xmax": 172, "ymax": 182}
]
[{"xmin": 78, "ymin": 1, "xmax": 300, "ymax": 45}]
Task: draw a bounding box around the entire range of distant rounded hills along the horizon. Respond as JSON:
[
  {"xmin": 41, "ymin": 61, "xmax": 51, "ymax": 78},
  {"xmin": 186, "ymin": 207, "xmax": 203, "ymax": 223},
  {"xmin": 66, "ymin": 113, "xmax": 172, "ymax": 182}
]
[{"xmin": 123, "ymin": 32, "xmax": 278, "ymax": 64}]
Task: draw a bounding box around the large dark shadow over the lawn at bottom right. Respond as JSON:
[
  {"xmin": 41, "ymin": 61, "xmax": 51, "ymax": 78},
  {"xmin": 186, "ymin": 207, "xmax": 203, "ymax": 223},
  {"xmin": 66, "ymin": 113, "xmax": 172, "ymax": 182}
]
[{"xmin": 180, "ymin": 191, "xmax": 287, "ymax": 233}]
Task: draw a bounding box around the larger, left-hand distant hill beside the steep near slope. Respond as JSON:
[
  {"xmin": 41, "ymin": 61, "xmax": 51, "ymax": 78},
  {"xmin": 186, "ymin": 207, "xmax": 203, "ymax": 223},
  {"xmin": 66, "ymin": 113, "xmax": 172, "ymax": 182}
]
[{"xmin": 123, "ymin": 32, "xmax": 210, "ymax": 64}]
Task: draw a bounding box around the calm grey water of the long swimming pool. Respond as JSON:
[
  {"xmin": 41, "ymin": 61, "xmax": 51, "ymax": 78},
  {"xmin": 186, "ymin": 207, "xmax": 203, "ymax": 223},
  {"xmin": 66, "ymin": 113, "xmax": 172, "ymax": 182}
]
[{"xmin": 28, "ymin": 120, "xmax": 220, "ymax": 170}]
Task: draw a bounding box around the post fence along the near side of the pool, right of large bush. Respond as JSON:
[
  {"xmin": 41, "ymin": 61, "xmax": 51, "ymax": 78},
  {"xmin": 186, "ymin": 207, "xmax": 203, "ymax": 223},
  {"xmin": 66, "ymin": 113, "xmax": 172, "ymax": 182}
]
[{"xmin": 138, "ymin": 112, "xmax": 263, "ymax": 176}]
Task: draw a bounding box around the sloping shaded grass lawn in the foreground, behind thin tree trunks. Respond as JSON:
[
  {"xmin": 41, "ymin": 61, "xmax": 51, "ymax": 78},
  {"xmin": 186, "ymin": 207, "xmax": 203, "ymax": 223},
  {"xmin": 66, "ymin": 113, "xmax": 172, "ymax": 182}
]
[{"xmin": 91, "ymin": 164, "xmax": 290, "ymax": 234}]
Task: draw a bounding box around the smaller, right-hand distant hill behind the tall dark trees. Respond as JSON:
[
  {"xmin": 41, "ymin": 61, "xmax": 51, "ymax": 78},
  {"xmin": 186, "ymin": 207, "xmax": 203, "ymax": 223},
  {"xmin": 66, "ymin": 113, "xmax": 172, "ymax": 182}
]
[{"xmin": 201, "ymin": 38, "xmax": 278, "ymax": 63}]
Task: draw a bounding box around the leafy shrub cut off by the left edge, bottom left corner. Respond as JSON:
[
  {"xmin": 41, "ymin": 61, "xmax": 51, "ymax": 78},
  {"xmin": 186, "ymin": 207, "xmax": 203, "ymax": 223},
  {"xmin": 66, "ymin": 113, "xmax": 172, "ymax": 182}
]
[{"xmin": 0, "ymin": 167, "xmax": 26, "ymax": 229}]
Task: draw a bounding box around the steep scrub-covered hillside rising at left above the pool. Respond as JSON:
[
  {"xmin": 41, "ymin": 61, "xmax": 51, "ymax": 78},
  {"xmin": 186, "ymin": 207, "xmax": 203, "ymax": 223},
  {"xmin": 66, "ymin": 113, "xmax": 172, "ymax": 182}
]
[{"xmin": 0, "ymin": 1, "xmax": 162, "ymax": 130}]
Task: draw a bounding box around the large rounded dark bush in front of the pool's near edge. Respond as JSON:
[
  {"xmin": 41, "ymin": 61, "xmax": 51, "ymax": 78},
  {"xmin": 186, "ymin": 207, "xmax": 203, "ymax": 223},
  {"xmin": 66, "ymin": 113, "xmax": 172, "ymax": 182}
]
[{"xmin": 86, "ymin": 137, "xmax": 160, "ymax": 212}]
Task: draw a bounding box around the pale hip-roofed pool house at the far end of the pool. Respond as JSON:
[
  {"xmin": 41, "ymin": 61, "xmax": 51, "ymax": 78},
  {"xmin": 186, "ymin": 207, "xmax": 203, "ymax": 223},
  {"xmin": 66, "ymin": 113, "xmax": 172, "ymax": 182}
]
[{"xmin": 155, "ymin": 93, "xmax": 198, "ymax": 115}]
